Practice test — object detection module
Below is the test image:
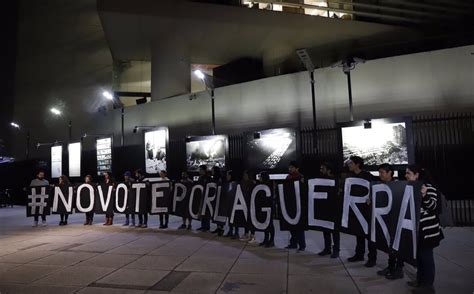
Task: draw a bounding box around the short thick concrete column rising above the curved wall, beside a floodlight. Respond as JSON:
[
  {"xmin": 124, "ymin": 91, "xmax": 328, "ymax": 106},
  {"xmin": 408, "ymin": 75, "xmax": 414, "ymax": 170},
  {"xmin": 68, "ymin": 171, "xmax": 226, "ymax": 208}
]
[{"xmin": 151, "ymin": 39, "xmax": 191, "ymax": 100}]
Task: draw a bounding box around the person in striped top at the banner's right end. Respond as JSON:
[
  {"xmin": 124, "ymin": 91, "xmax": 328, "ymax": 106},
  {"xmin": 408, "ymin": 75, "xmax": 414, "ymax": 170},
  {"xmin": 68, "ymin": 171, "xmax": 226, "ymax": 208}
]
[{"xmin": 405, "ymin": 165, "xmax": 444, "ymax": 293}]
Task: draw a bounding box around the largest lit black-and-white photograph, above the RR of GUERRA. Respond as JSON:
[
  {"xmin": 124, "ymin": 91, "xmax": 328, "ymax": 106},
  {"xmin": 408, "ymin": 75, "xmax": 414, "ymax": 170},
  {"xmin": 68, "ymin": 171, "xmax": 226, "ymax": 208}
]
[{"xmin": 341, "ymin": 121, "xmax": 408, "ymax": 166}]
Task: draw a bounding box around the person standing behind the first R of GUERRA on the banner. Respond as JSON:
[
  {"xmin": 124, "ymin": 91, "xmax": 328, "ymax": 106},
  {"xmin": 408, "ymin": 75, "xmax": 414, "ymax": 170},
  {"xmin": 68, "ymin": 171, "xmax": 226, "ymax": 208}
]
[{"xmin": 347, "ymin": 156, "xmax": 377, "ymax": 267}]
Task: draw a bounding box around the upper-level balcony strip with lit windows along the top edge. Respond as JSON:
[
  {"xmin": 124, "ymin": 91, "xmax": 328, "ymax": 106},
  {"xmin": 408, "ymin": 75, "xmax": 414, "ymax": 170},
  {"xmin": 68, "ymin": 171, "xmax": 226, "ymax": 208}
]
[{"xmin": 191, "ymin": 0, "xmax": 474, "ymax": 26}]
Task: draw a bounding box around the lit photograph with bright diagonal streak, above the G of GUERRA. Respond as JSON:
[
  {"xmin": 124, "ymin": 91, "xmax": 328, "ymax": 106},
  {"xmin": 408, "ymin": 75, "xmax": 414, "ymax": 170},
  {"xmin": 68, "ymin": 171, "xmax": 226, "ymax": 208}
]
[{"xmin": 246, "ymin": 128, "xmax": 296, "ymax": 170}]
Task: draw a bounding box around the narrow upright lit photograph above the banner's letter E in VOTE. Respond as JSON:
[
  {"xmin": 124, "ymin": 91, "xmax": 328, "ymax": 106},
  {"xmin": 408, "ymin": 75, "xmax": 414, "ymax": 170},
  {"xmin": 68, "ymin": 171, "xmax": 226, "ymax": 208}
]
[{"xmin": 145, "ymin": 129, "xmax": 168, "ymax": 174}]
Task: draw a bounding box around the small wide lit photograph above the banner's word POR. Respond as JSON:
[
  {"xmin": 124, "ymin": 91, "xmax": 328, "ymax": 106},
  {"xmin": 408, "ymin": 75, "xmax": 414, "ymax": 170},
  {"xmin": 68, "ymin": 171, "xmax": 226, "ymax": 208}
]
[{"xmin": 186, "ymin": 136, "xmax": 227, "ymax": 172}]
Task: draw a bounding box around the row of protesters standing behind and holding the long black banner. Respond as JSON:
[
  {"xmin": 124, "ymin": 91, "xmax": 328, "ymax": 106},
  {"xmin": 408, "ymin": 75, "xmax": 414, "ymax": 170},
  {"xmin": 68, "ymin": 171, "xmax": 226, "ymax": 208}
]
[{"xmin": 31, "ymin": 156, "xmax": 443, "ymax": 293}]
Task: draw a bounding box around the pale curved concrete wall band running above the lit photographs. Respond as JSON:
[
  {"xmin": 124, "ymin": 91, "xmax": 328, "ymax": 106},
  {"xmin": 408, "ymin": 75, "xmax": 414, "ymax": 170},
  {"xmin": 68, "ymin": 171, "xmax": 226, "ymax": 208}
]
[{"xmin": 116, "ymin": 46, "xmax": 474, "ymax": 144}]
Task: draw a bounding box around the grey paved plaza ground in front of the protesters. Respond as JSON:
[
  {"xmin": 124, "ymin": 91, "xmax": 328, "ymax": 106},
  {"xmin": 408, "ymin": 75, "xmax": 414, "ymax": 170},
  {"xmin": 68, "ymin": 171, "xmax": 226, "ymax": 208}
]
[{"xmin": 0, "ymin": 207, "xmax": 474, "ymax": 294}]
